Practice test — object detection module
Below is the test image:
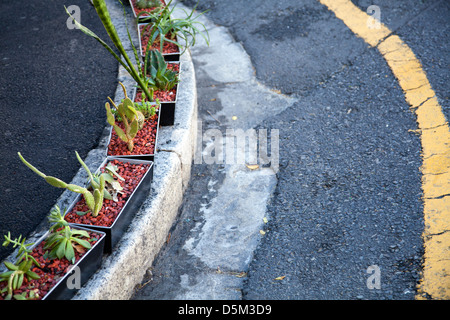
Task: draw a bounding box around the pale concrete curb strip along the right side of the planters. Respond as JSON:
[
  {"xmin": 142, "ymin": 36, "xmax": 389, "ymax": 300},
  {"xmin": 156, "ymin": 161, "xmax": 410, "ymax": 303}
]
[{"xmin": 74, "ymin": 48, "xmax": 197, "ymax": 300}]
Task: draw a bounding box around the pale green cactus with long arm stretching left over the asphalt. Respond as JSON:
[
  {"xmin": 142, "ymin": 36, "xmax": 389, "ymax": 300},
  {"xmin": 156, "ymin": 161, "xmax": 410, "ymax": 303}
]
[{"xmin": 18, "ymin": 151, "xmax": 106, "ymax": 217}]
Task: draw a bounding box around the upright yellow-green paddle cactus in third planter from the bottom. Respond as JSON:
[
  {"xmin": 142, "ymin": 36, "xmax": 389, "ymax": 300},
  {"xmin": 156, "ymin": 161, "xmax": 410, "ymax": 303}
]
[{"xmin": 105, "ymin": 82, "xmax": 145, "ymax": 151}]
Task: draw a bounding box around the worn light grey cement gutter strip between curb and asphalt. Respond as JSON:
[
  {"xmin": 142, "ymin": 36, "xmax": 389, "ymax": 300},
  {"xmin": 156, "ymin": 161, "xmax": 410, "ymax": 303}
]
[{"xmin": 133, "ymin": 3, "xmax": 296, "ymax": 300}]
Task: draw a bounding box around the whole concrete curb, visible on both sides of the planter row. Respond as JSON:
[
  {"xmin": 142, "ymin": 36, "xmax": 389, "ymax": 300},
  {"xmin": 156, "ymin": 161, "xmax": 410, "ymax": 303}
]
[{"xmin": 0, "ymin": 0, "xmax": 197, "ymax": 300}]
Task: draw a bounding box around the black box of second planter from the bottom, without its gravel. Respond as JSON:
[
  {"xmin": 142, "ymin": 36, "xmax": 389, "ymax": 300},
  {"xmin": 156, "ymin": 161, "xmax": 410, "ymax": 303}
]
[{"xmin": 66, "ymin": 157, "xmax": 154, "ymax": 254}]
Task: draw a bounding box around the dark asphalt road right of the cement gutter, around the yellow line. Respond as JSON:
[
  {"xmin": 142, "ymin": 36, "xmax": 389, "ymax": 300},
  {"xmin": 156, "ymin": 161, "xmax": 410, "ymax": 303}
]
[{"xmin": 178, "ymin": 0, "xmax": 450, "ymax": 300}]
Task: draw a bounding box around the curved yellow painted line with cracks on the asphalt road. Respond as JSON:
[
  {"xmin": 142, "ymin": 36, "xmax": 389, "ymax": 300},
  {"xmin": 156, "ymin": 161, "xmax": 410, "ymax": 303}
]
[{"xmin": 319, "ymin": 0, "xmax": 450, "ymax": 300}]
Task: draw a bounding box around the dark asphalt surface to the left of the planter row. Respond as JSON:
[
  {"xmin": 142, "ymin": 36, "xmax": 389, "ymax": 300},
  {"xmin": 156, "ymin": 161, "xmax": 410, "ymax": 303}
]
[{"xmin": 0, "ymin": 0, "xmax": 117, "ymax": 260}]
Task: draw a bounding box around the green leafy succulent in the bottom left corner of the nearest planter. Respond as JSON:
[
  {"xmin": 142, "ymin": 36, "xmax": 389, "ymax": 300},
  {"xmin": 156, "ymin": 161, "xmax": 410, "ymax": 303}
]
[{"xmin": 0, "ymin": 232, "xmax": 40, "ymax": 300}]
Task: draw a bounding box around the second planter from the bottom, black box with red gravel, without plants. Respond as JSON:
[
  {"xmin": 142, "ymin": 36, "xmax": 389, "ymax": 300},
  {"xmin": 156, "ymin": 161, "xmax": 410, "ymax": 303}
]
[{"xmin": 64, "ymin": 157, "xmax": 154, "ymax": 253}]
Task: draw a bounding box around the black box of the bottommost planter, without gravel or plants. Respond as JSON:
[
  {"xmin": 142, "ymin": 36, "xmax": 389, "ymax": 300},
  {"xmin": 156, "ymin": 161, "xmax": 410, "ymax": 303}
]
[{"xmin": 32, "ymin": 226, "xmax": 106, "ymax": 300}]
